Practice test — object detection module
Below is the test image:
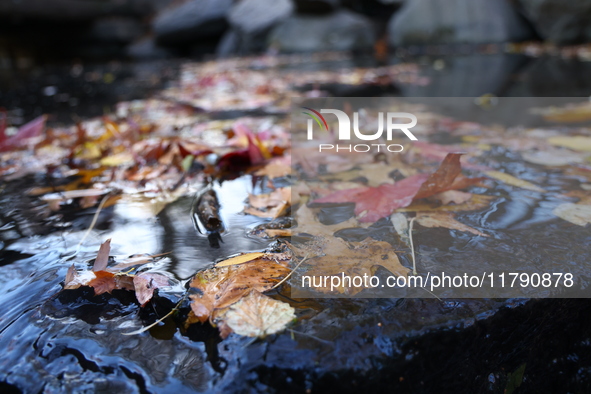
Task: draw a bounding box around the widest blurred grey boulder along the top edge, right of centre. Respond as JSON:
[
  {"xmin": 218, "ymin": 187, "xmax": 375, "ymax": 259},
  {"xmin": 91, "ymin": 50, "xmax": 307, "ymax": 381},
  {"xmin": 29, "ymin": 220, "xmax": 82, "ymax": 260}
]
[{"xmin": 388, "ymin": 0, "xmax": 535, "ymax": 45}]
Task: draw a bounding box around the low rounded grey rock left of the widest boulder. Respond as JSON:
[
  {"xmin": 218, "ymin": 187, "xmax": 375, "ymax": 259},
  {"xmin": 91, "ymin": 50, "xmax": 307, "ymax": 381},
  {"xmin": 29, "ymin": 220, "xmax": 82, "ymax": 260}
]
[{"xmin": 269, "ymin": 10, "xmax": 375, "ymax": 52}]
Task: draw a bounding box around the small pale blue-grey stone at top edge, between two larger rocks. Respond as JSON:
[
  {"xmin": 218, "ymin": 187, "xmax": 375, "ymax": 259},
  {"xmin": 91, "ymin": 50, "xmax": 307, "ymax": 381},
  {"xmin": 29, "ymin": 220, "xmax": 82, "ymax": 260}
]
[{"xmin": 228, "ymin": 0, "xmax": 294, "ymax": 33}]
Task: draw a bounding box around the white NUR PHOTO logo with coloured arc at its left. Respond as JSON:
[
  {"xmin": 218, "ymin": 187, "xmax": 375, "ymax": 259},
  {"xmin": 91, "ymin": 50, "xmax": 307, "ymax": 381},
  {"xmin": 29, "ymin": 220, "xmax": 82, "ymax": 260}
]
[{"xmin": 302, "ymin": 107, "xmax": 417, "ymax": 152}]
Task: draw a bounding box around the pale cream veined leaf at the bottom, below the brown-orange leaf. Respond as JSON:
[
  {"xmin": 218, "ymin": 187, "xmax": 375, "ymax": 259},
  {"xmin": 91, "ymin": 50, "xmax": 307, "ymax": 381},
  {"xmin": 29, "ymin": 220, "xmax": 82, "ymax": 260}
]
[{"xmin": 222, "ymin": 291, "xmax": 295, "ymax": 338}]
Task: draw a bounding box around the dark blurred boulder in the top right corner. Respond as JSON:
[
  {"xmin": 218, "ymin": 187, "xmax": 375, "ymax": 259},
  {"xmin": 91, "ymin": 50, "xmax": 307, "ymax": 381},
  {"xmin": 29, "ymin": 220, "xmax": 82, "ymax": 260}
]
[{"xmin": 519, "ymin": 0, "xmax": 591, "ymax": 44}]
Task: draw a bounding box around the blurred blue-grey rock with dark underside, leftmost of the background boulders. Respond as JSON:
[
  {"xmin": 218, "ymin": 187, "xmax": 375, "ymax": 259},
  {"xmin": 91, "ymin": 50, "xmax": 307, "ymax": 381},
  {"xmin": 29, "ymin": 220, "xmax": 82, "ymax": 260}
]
[{"xmin": 152, "ymin": 0, "xmax": 233, "ymax": 45}]
